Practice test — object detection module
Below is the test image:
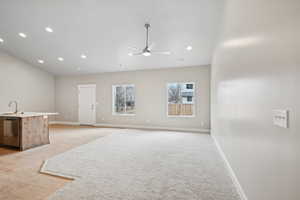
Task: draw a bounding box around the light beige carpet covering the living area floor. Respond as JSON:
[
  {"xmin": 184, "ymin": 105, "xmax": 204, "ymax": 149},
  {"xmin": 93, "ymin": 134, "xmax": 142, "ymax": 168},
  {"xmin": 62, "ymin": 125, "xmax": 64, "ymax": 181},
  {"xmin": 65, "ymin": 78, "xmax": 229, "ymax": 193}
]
[{"xmin": 42, "ymin": 130, "xmax": 239, "ymax": 200}]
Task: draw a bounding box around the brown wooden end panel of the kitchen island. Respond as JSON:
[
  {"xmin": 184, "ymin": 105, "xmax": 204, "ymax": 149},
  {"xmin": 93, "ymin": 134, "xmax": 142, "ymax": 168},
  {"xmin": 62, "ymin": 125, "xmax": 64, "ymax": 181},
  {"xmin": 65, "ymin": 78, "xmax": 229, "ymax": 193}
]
[{"xmin": 20, "ymin": 116, "xmax": 50, "ymax": 150}]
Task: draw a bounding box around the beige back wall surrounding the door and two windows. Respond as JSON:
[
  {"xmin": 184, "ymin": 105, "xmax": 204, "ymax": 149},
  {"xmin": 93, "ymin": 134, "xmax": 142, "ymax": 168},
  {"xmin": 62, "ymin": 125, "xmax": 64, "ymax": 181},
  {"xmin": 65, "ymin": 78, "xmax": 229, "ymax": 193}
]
[{"xmin": 55, "ymin": 66, "xmax": 210, "ymax": 129}]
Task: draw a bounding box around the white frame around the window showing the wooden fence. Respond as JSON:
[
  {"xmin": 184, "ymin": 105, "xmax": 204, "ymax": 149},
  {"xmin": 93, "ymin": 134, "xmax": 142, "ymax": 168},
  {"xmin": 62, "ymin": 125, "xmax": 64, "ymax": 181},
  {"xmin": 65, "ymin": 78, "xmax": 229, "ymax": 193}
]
[{"xmin": 166, "ymin": 81, "xmax": 197, "ymax": 118}]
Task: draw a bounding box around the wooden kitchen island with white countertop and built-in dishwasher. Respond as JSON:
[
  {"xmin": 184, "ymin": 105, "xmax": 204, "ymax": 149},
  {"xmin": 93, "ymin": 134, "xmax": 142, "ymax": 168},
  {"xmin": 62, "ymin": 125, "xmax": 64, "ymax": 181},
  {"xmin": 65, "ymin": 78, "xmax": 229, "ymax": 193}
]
[{"xmin": 0, "ymin": 112, "xmax": 57, "ymax": 151}]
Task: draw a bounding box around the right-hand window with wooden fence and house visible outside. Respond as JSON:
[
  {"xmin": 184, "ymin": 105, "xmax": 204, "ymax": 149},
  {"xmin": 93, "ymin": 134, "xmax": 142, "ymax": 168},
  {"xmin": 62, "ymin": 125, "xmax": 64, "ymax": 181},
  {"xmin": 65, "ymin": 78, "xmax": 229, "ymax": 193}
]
[{"xmin": 167, "ymin": 83, "xmax": 195, "ymax": 117}]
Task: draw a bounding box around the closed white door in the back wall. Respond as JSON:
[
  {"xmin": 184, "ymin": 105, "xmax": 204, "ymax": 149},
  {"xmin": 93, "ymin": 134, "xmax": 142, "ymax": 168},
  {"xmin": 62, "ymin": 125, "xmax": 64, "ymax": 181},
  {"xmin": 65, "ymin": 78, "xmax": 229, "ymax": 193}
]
[{"xmin": 78, "ymin": 85, "xmax": 96, "ymax": 125}]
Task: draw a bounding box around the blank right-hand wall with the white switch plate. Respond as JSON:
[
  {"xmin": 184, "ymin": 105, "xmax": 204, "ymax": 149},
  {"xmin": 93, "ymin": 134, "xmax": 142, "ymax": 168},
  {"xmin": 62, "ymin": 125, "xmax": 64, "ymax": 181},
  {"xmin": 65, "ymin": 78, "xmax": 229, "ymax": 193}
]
[{"xmin": 212, "ymin": 0, "xmax": 300, "ymax": 200}]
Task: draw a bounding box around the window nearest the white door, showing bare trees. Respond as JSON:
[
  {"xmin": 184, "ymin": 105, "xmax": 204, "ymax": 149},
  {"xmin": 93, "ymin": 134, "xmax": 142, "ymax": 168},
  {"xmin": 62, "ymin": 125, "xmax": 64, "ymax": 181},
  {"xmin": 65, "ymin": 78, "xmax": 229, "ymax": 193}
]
[{"xmin": 113, "ymin": 85, "xmax": 135, "ymax": 115}]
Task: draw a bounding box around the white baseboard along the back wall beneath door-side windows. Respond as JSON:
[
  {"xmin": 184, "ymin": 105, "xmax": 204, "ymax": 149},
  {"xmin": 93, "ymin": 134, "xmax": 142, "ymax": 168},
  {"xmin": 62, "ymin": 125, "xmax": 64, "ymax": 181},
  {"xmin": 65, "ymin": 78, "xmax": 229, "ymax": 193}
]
[{"xmin": 49, "ymin": 121, "xmax": 210, "ymax": 133}]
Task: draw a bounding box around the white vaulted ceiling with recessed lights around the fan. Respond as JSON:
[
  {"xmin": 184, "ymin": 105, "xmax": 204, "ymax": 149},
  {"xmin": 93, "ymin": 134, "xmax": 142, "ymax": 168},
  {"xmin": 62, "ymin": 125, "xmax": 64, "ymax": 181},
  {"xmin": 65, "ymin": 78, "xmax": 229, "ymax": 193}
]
[{"xmin": 0, "ymin": 0, "xmax": 223, "ymax": 74}]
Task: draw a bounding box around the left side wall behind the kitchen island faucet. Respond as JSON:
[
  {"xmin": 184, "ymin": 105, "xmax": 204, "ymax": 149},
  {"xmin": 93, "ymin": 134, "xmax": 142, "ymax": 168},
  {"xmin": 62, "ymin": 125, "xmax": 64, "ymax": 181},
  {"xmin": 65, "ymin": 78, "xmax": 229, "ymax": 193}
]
[{"xmin": 0, "ymin": 51, "xmax": 55, "ymax": 112}]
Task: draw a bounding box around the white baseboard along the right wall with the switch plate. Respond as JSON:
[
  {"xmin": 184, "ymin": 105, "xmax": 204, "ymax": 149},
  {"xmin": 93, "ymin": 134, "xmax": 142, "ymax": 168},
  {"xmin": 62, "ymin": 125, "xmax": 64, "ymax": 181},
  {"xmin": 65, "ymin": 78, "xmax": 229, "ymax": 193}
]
[{"xmin": 211, "ymin": 135, "xmax": 248, "ymax": 200}]
